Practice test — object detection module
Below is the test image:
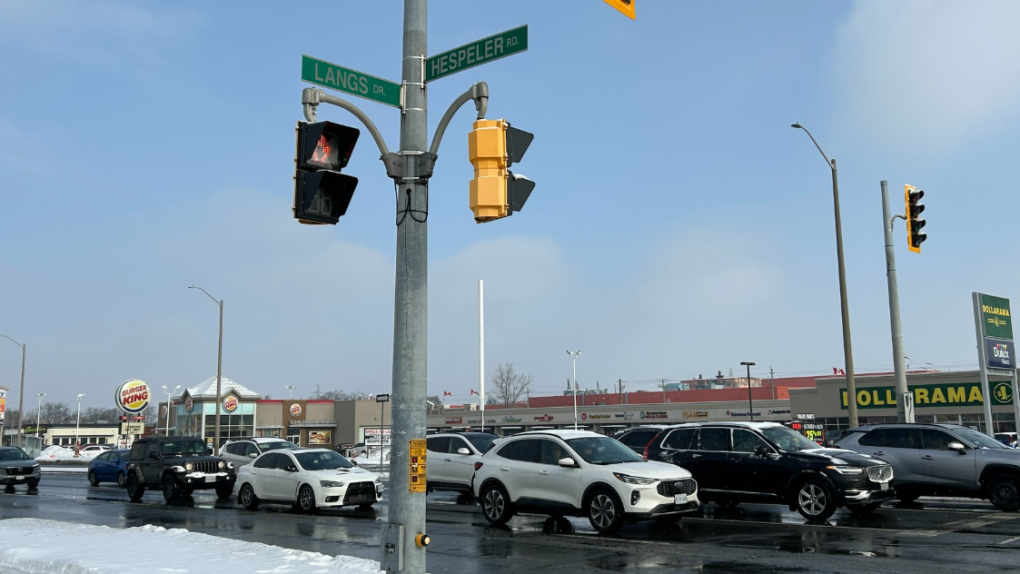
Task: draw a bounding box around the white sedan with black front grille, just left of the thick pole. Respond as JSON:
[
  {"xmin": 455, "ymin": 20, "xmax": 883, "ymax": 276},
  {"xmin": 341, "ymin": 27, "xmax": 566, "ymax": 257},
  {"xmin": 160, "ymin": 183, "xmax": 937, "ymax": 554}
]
[{"xmin": 237, "ymin": 449, "xmax": 383, "ymax": 512}]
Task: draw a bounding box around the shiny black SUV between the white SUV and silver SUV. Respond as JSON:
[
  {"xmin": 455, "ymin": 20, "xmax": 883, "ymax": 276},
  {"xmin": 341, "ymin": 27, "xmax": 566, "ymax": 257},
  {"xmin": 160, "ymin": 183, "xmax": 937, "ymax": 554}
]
[{"xmin": 648, "ymin": 422, "xmax": 896, "ymax": 520}]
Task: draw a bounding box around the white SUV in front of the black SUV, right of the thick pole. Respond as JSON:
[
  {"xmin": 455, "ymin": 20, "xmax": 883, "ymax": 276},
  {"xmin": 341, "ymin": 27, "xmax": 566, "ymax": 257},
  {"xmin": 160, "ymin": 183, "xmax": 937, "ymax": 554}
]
[{"xmin": 472, "ymin": 430, "xmax": 701, "ymax": 532}]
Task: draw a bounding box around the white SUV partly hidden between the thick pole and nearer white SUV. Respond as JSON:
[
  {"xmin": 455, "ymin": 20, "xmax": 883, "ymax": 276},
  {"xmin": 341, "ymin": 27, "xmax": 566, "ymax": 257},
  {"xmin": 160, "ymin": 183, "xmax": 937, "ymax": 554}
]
[{"xmin": 425, "ymin": 432, "xmax": 499, "ymax": 494}]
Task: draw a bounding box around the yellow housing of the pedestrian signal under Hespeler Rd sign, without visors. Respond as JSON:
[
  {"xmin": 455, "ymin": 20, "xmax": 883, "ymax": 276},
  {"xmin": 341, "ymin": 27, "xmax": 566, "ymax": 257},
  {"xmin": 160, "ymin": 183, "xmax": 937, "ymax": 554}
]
[{"xmin": 467, "ymin": 119, "xmax": 509, "ymax": 223}]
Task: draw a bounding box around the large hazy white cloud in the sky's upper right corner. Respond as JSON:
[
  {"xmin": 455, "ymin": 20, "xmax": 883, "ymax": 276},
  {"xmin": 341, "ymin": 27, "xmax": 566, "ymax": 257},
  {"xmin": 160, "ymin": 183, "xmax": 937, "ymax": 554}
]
[{"xmin": 830, "ymin": 0, "xmax": 1020, "ymax": 153}]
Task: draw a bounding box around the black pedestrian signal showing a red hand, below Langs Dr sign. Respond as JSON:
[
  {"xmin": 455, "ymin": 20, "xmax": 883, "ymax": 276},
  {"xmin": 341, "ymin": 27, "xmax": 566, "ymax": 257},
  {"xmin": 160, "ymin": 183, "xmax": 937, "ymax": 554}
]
[{"xmin": 294, "ymin": 121, "xmax": 361, "ymax": 225}]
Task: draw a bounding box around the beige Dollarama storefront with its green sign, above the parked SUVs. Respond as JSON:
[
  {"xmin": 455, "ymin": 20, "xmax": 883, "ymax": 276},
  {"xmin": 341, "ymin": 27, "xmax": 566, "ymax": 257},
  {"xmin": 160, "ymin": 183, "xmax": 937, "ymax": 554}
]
[{"xmin": 789, "ymin": 370, "xmax": 1016, "ymax": 437}]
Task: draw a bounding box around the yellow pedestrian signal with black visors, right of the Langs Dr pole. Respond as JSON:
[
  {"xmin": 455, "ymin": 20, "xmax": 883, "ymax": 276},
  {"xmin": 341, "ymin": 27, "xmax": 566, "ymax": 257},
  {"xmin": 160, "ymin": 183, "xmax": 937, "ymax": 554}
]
[{"xmin": 467, "ymin": 119, "xmax": 534, "ymax": 223}]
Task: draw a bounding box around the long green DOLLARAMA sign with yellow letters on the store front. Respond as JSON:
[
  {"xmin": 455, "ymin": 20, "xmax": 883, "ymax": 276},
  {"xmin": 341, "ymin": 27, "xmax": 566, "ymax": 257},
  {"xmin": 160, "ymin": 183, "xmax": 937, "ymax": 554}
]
[{"xmin": 839, "ymin": 381, "xmax": 1013, "ymax": 411}]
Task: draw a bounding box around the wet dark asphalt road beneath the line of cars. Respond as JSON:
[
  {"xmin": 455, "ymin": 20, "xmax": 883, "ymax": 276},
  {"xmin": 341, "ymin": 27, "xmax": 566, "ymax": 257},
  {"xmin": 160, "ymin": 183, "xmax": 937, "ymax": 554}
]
[{"xmin": 0, "ymin": 473, "xmax": 1020, "ymax": 574}]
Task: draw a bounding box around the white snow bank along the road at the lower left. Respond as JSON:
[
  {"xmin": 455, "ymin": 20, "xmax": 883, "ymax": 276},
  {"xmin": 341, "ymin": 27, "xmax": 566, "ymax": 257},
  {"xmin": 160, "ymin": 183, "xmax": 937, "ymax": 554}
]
[{"xmin": 0, "ymin": 518, "xmax": 379, "ymax": 574}]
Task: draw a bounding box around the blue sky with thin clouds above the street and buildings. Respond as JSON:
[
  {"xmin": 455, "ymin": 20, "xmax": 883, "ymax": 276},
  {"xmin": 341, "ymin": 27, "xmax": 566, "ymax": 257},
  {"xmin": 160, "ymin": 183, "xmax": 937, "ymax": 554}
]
[{"xmin": 0, "ymin": 0, "xmax": 1020, "ymax": 413}]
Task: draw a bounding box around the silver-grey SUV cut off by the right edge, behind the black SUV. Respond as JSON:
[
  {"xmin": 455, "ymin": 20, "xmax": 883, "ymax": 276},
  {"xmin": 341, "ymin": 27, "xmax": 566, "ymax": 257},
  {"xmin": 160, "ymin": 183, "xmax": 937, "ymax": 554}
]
[{"xmin": 835, "ymin": 423, "xmax": 1020, "ymax": 511}]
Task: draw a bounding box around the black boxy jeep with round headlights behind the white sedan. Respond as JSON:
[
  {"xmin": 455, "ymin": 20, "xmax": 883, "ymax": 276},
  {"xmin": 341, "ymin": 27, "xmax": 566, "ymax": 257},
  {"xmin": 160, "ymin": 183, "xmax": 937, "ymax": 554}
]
[{"xmin": 125, "ymin": 436, "xmax": 237, "ymax": 503}]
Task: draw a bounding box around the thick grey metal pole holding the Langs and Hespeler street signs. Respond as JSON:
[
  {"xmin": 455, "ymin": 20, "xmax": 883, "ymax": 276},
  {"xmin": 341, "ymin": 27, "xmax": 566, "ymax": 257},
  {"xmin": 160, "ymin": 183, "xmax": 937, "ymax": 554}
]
[{"xmin": 383, "ymin": 0, "xmax": 428, "ymax": 574}]
